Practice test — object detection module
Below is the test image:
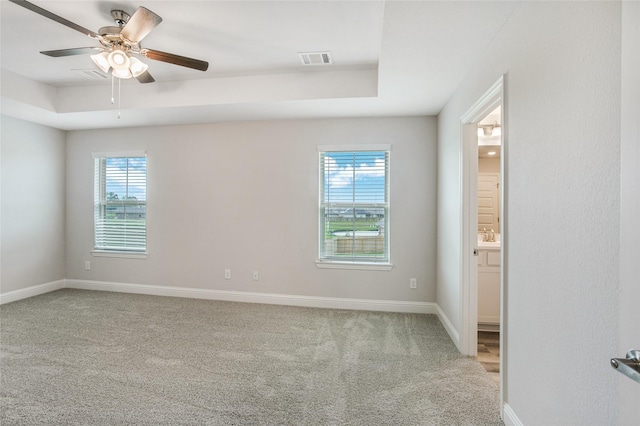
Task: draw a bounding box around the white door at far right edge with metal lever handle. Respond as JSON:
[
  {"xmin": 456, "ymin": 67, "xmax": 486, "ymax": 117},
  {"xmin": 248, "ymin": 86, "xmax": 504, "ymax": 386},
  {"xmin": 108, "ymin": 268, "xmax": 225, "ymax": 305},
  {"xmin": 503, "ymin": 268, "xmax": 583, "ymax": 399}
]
[{"xmin": 612, "ymin": 2, "xmax": 640, "ymax": 425}]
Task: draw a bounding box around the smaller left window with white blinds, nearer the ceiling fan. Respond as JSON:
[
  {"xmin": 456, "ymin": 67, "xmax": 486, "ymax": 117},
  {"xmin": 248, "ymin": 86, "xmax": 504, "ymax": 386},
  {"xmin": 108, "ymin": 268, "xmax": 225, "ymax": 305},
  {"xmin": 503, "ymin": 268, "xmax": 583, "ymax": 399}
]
[{"xmin": 94, "ymin": 153, "xmax": 147, "ymax": 254}]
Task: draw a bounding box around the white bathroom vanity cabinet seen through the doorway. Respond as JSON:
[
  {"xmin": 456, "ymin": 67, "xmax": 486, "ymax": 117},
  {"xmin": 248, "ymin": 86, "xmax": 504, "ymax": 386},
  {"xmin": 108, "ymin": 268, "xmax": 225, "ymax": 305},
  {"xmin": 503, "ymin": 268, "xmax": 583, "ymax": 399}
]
[{"xmin": 478, "ymin": 247, "xmax": 500, "ymax": 329}]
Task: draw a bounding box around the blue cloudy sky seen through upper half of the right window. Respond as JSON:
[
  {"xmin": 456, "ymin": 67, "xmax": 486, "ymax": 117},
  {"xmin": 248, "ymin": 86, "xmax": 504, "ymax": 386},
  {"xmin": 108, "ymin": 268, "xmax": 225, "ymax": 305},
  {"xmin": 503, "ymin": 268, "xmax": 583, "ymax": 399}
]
[{"xmin": 324, "ymin": 151, "xmax": 386, "ymax": 203}]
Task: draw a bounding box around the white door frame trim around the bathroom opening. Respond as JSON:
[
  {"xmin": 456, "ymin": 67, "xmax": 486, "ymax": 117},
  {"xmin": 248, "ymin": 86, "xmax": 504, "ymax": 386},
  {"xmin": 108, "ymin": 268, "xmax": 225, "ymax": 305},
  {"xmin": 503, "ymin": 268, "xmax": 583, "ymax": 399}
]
[{"xmin": 460, "ymin": 75, "xmax": 508, "ymax": 406}]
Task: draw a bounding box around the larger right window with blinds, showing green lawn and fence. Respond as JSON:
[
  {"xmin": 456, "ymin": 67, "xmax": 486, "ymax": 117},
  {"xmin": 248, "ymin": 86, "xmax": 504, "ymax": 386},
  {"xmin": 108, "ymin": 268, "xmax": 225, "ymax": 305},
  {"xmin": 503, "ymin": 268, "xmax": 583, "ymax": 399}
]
[{"xmin": 318, "ymin": 145, "xmax": 390, "ymax": 264}]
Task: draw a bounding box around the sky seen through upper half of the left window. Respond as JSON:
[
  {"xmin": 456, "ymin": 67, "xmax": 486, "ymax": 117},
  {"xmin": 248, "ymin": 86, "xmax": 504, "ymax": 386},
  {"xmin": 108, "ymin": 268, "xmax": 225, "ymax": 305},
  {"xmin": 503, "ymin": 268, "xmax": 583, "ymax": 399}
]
[{"xmin": 105, "ymin": 157, "xmax": 147, "ymax": 201}]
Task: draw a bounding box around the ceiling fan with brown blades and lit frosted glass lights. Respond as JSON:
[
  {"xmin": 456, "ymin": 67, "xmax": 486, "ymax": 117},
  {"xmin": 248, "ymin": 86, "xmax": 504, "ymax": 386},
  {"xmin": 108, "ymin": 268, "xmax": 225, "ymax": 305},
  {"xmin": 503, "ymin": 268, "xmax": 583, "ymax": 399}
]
[{"xmin": 9, "ymin": 0, "xmax": 209, "ymax": 83}]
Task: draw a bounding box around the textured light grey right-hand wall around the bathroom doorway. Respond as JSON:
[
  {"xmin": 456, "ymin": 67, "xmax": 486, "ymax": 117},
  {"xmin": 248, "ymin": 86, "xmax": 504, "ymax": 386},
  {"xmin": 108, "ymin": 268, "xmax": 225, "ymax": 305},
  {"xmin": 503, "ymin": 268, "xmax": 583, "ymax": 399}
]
[{"xmin": 437, "ymin": 2, "xmax": 621, "ymax": 425}]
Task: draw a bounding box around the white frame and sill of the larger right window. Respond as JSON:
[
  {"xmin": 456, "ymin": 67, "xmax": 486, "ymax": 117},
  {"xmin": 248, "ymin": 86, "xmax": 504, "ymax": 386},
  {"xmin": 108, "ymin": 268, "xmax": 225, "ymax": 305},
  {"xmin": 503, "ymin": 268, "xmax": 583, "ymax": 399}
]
[{"xmin": 315, "ymin": 144, "xmax": 393, "ymax": 271}]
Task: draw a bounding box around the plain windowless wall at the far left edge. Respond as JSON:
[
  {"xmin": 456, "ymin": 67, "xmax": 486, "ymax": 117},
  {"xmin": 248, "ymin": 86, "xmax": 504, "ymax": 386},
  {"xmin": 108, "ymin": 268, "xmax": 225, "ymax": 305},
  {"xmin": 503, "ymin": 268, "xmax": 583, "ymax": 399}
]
[{"xmin": 0, "ymin": 115, "xmax": 65, "ymax": 293}]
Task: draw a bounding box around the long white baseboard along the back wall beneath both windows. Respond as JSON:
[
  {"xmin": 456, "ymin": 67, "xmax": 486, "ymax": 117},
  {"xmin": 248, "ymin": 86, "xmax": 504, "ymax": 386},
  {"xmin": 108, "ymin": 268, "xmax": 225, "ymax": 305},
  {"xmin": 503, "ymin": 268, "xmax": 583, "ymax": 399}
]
[{"xmin": 65, "ymin": 279, "xmax": 436, "ymax": 314}]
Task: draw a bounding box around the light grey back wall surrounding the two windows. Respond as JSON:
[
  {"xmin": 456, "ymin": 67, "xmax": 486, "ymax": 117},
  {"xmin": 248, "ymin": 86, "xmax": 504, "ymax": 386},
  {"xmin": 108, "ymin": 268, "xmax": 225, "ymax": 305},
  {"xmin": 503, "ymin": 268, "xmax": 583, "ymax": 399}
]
[{"xmin": 67, "ymin": 117, "xmax": 437, "ymax": 302}]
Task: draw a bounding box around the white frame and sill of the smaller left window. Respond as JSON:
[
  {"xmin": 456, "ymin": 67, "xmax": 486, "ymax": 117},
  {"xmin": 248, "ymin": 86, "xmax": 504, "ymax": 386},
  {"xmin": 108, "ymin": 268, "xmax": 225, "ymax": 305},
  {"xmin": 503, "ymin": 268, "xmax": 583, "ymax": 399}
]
[{"xmin": 91, "ymin": 151, "xmax": 149, "ymax": 259}]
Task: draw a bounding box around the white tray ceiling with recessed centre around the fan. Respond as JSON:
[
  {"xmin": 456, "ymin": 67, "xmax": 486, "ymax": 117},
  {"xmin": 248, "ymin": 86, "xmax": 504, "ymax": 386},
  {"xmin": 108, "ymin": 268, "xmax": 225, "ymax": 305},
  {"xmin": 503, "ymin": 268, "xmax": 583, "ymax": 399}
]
[{"xmin": 0, "ymin": 0, "xmax": 517, "ymax": 130}]
